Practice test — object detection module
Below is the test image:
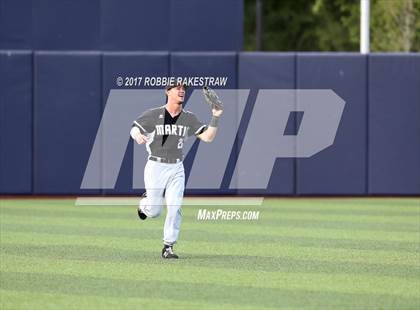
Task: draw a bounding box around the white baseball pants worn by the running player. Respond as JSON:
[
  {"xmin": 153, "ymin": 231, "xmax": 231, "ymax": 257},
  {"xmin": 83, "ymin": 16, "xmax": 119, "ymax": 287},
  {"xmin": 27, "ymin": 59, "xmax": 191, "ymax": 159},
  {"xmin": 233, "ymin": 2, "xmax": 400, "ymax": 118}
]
[{"xmin": 140, "ymin": 160, "xmax": 185, "ymax": 245}]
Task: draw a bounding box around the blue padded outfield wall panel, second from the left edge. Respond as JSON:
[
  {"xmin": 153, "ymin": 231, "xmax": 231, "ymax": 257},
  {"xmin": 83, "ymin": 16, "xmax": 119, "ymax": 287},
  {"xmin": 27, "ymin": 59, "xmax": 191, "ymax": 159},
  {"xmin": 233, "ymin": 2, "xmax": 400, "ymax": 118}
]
[{"xmin": 34, "ymin": 52, "xmax": 102, "ymax": 194}]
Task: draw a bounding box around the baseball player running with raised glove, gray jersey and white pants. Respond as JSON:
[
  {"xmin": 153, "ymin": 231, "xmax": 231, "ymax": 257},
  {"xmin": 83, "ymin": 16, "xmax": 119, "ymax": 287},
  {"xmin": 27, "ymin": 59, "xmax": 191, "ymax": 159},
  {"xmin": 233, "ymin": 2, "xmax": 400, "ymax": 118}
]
[{"xmin": 130, "ymin": 84, "xmax": 223, "ymax": 259}]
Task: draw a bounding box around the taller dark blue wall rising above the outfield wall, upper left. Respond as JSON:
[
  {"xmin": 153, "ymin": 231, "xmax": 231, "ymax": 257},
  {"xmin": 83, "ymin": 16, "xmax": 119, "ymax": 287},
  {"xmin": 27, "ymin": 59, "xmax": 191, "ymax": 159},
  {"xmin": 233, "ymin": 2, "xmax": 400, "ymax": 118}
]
[{"xmin": 0, "ymin": 0, "xmax": 243, "ymax": 51}]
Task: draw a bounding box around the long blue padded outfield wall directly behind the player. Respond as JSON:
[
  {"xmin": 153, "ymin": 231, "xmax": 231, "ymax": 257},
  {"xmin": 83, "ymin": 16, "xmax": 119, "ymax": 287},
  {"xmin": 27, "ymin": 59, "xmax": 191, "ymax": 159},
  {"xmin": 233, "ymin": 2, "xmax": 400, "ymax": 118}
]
[{"xmin": 0, "ymin": 50, "xmax": 420, "ymax": 195}]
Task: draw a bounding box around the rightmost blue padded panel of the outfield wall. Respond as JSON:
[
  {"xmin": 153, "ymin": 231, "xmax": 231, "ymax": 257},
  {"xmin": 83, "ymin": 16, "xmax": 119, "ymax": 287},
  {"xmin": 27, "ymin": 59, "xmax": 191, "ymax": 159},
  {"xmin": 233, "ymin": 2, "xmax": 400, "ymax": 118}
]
[{"xmin": 368, "ymin": 54, "xmax": 420, "ymax": 195}]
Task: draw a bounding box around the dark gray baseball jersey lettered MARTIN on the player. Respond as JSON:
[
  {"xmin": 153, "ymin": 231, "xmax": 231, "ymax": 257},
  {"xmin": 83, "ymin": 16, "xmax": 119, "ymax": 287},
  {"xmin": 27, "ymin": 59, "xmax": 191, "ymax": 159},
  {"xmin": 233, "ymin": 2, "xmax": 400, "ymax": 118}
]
[{"xmin": 133, "ymin": 106, "xmax": 207, "ymax": 159}]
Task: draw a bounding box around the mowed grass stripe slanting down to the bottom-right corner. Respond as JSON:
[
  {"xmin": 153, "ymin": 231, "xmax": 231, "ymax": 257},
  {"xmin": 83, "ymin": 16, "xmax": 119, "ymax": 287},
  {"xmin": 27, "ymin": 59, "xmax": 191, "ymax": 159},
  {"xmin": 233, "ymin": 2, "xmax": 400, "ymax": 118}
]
[{"xmin": 2, "ymin": 274, "xmax": 419, "ymax": 309}]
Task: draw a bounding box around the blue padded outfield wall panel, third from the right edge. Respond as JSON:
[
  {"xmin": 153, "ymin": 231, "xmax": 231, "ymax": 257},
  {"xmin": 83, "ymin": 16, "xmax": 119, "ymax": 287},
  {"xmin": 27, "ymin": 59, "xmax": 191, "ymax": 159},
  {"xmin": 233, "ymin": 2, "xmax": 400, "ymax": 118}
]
[{"xmin": 238, "ymin": 53, "xmax": 296, "ymax": 195}]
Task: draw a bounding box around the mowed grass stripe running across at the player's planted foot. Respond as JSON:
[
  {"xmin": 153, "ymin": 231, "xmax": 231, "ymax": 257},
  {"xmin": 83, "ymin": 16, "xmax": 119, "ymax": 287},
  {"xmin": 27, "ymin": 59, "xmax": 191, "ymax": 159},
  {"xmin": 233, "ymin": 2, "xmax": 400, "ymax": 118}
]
[{"xmin": 0, "ymin": 244, "xmax": 420, "ymax": 279}]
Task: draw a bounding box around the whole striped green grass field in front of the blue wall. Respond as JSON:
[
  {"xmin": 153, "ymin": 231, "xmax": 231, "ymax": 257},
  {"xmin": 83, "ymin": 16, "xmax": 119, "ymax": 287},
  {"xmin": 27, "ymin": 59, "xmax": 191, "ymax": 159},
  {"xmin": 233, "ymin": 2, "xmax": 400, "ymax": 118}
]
[{"xmin": 0, "ymin": 198, "xmax": 420, "ymax": 310}]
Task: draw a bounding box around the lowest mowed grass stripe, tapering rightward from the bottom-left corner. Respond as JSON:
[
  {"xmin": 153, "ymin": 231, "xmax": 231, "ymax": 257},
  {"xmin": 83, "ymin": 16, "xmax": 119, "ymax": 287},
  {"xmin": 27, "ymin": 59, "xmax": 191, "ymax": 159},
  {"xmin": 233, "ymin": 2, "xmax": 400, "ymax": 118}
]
[{"xmin": 0, "ymin": 288, "xmax": 273, "ymax": 310}]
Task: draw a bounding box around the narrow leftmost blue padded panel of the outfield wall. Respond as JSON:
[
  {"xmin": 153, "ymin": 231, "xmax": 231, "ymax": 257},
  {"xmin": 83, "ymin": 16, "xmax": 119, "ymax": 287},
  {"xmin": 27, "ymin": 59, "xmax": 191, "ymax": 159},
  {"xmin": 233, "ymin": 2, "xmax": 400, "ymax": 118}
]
[{"xmin": 0, "ymin": 51, "xmax": 32, "ymax": 194}]
